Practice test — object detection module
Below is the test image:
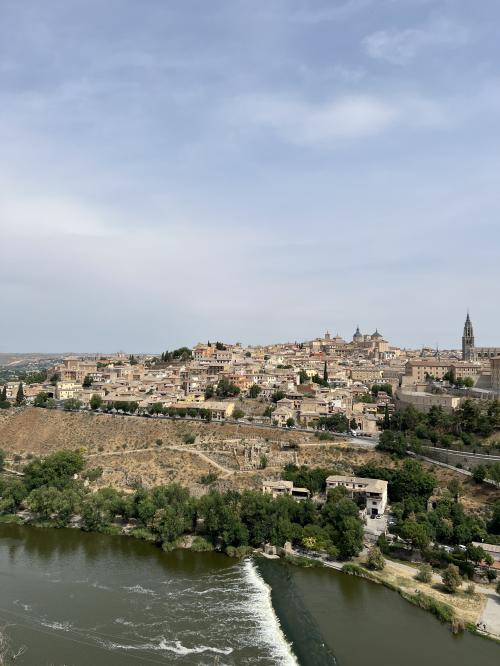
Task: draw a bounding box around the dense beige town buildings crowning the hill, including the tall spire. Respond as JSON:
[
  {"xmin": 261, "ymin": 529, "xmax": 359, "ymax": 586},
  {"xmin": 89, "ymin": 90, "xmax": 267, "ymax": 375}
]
[{"xmin": 2, "ymin": 315, "xmax": 500, "ymax": 426}]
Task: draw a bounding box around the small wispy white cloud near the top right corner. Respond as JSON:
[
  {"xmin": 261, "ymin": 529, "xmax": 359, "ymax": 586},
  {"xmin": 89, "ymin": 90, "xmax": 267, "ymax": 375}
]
[{"xmin": 363, "ymin": 20, "xmax": 470, "ymax": 65}]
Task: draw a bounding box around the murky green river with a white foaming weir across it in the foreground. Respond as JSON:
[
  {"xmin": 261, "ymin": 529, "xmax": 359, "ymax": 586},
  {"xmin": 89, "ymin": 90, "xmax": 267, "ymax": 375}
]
[{"xmin": 0, "ymin": 525, "xmax": 500, "ymax": 666}]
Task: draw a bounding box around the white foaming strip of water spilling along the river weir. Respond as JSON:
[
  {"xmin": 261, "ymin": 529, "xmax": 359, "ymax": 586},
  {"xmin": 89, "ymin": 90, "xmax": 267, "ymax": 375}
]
[{"xmin": 242, "ymin": 559, "xmax": 299, "ymax": 666}]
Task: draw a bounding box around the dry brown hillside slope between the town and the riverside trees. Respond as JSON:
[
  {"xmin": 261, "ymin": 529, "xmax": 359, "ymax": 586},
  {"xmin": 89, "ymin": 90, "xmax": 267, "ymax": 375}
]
[{"xmin": 0, "ymin": 407, "xmax": 497, "ymax": 508}]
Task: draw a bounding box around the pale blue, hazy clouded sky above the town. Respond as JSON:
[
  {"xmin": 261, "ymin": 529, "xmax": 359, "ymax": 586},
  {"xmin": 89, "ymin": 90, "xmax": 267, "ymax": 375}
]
[{"xmin": 0, "ymin": 0, "xmax": 500, "ymax": 352}]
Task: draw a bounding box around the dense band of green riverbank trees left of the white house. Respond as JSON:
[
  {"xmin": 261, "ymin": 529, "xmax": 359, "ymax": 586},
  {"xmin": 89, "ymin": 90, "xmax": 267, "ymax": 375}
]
[{"xmin": 0, "ymin": 451, "xmax": 363, "ymax": 558}]
